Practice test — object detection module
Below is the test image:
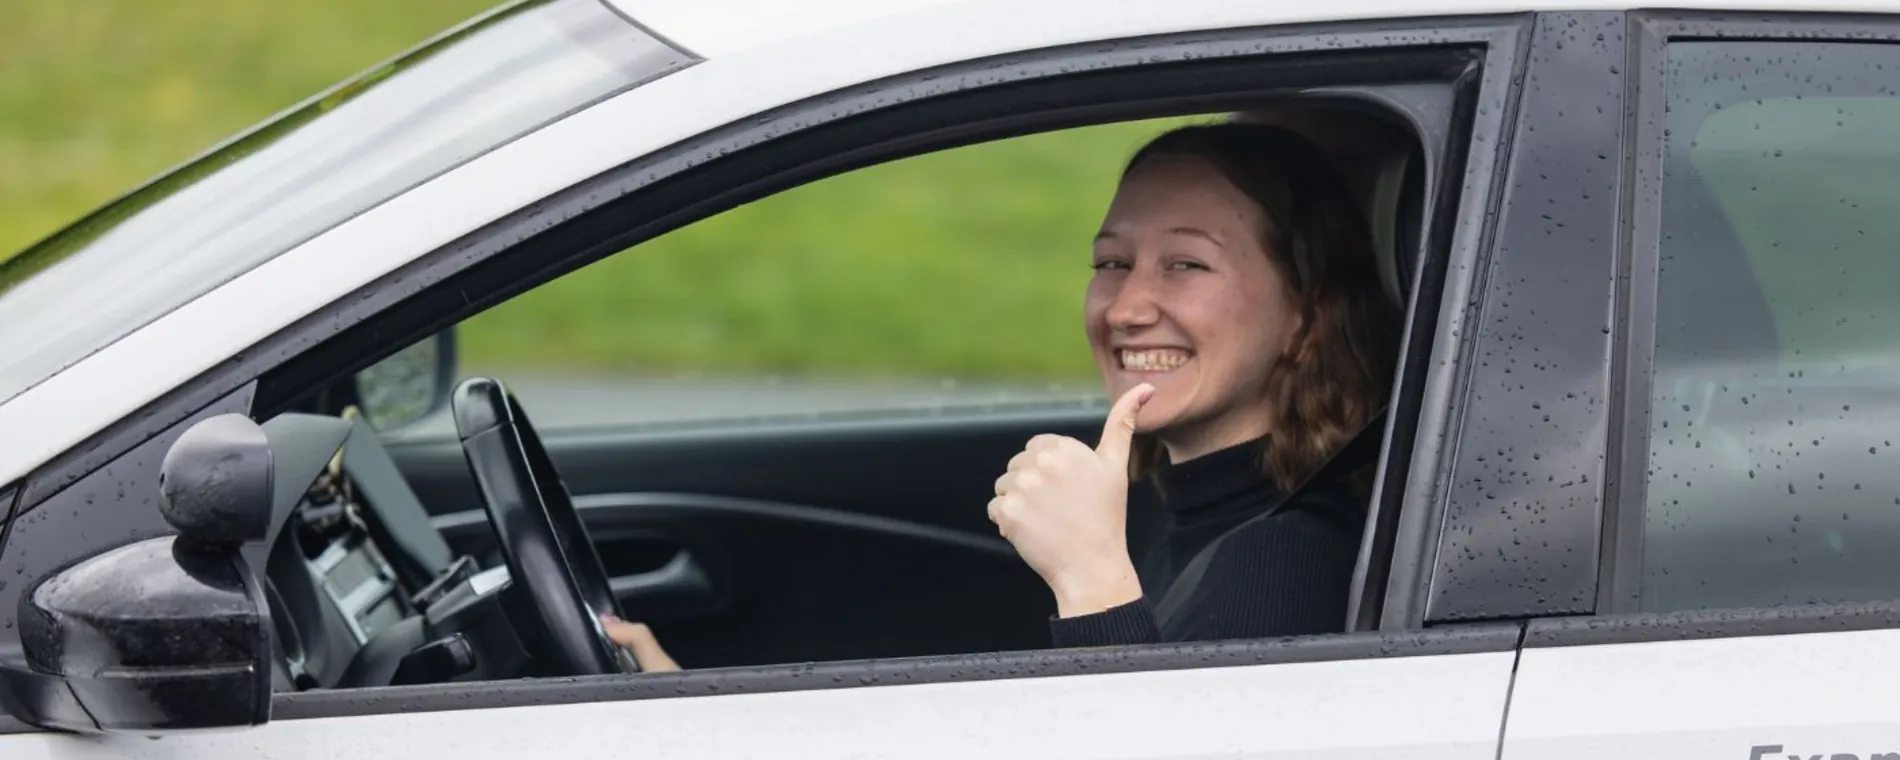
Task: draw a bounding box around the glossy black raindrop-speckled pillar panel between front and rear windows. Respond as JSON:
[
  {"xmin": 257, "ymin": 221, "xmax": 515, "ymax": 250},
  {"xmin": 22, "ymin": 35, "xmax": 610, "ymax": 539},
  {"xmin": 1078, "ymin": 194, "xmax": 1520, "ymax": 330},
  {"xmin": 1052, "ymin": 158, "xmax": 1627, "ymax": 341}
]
[{"xmin": 1421, "ymin": 11, "xmax": 1626, "ymax": 625}]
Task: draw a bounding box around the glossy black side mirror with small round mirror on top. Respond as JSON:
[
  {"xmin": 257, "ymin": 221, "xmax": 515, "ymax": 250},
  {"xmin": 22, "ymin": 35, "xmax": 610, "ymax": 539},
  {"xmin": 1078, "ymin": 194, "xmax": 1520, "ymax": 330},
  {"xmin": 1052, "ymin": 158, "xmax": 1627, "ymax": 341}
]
[{"xmin": 0, "ymin": 414, "xmax": 272, "ymax": 733}]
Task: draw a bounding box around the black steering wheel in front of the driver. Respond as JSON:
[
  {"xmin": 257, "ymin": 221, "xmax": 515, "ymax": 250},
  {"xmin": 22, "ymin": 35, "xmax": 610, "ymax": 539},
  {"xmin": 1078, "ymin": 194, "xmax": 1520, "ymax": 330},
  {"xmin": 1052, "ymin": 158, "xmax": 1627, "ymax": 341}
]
[{"xmin": 448, "ymin": 378, "xmax": 640, "ymax": 676}]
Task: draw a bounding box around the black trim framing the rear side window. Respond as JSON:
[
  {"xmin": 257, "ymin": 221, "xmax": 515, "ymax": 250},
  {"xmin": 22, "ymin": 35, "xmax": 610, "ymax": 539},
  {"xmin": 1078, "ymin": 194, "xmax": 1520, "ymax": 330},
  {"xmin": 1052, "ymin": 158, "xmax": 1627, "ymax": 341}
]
[{"xmin": 1596, "ymin": 11, "xmax": 1900, "ymax": 623}]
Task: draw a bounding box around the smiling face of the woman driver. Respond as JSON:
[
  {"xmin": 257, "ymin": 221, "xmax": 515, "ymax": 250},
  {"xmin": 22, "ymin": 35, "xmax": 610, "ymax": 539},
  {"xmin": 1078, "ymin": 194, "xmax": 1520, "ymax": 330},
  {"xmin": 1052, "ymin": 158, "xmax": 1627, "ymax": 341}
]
[{"xmin": 1083, "ymin": 156, "xmax": 1298, "ymax": 462}]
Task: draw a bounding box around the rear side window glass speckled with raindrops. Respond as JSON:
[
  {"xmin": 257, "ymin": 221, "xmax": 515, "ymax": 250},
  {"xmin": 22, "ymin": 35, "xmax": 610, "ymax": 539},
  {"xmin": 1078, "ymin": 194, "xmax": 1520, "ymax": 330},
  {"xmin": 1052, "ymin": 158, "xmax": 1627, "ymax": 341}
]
[{"xmin": 1642, "ymin": 42, "xmax": 1900, "ymax": 612}]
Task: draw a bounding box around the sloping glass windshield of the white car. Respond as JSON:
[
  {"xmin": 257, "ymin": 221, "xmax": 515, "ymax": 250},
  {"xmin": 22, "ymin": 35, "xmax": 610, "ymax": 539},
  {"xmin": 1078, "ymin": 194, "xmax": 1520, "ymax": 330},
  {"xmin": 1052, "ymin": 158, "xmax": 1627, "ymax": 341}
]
[{"xmin": 0, "ymin": 0, "xmax": 686, "ymax": 401}]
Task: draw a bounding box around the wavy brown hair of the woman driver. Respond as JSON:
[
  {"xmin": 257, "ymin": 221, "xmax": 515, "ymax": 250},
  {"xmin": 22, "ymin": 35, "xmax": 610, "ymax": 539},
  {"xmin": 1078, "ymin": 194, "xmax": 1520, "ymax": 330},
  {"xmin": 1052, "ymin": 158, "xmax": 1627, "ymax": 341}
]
[{"xmin": 1123, "ymin": 124, "xmax": 1400, "ymax": 488}]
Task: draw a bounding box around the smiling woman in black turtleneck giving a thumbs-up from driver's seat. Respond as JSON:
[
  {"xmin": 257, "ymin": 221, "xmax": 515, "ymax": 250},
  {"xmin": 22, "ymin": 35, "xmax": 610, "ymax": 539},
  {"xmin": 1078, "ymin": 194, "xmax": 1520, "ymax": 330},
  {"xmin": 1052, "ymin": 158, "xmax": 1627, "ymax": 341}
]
[{"xmin": 990, "ymin": 124, "xmax": 1400, "ymax": 646}]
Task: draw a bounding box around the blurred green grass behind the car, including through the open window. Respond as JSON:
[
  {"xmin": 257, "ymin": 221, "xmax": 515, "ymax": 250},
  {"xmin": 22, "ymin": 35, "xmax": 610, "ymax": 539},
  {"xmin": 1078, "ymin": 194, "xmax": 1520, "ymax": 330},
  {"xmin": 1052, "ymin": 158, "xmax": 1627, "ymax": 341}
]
[{"xmin": 0, "ymin": 0, "xmax": 1193, "ymax": 380}]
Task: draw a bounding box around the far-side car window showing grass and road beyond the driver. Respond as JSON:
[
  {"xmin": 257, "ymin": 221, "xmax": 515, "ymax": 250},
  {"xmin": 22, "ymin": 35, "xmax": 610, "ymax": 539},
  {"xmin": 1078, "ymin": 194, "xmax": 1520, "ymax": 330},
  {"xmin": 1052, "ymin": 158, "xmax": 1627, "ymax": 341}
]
[{"xmin": 440, "ymin": 120, "xmax": 1184, "ymax": 437}]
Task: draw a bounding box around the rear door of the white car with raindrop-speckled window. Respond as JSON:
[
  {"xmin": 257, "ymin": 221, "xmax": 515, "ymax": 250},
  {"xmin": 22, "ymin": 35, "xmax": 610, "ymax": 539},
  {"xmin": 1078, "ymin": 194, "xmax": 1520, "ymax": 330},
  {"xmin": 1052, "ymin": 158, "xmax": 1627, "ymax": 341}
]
[{"xmin": 1501, "ymin": 13, "xmax": 1900, "ymax": 760}]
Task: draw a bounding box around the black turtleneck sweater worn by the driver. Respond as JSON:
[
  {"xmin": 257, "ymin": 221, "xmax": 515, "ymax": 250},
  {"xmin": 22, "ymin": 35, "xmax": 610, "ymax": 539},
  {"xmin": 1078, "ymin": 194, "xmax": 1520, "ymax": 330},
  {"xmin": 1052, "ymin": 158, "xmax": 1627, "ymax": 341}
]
[{"xmin": 1049, "ymin": 441, "xmax": 1366, "ymax": 648}]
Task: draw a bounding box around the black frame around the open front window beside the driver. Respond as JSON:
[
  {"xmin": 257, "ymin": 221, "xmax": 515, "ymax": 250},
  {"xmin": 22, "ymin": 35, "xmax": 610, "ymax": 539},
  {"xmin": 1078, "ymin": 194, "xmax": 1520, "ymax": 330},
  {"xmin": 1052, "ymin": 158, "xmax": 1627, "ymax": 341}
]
[{"xmin": 0, "ymin": 13, "xmax": 1533, "ymax": 732}]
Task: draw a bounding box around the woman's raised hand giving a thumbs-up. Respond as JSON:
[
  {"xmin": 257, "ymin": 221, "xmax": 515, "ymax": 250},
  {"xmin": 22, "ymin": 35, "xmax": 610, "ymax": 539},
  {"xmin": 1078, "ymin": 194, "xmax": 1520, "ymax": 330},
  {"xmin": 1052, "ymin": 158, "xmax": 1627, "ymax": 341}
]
[{"xmin": 990, "ymin": 384, "xmax": 1155, "ymax": 618}]
